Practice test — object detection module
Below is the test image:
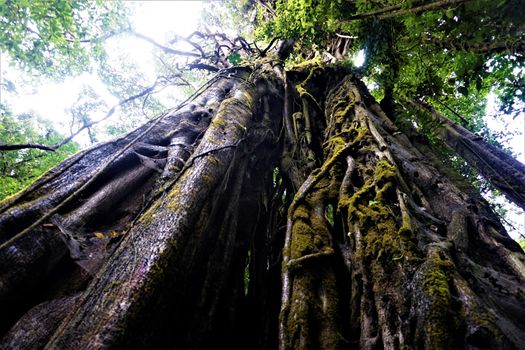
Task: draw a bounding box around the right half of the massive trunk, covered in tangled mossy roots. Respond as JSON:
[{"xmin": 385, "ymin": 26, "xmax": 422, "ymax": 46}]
[{"xmin": 279, "ymin": 71, "xmax": 525, "ymax": 349}]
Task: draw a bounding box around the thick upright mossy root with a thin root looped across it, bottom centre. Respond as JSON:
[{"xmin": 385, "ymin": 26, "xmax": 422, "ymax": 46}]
[{"xmin": 281, "ymin": 197, "xmax": 342, "ymax": 349}]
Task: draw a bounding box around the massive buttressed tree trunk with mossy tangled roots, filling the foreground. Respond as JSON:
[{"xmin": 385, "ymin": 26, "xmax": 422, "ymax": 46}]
[{"xmin": 0, "ymin": 65, "xmax": 525, "ymax": 349}]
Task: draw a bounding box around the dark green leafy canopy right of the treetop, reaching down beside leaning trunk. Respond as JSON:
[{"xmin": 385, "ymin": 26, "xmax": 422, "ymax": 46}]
[{"xmin": 257, "ymin": 0, "xmax": 525, "ymax": 237}]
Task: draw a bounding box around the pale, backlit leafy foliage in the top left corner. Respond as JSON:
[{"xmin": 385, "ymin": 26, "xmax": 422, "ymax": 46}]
[{"xmin": 0, "ymin": 0, "xmax": 127, "ymax": 77}]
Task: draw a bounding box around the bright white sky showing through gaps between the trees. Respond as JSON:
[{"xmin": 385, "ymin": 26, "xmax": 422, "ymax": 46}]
[{"xmin": 0, "ymin": 1, "xmax": 525, "ymax": 237}]
